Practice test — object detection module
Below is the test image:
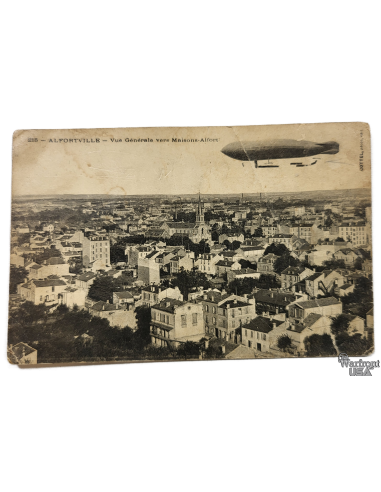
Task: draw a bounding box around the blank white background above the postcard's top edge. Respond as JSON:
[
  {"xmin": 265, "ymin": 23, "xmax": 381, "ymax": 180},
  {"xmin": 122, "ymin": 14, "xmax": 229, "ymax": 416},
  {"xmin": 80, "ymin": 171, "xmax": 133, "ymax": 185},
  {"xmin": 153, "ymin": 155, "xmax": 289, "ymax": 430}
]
[{"xmin": 0, "ymin": 0, "xmax": 380, "ymax": 114}]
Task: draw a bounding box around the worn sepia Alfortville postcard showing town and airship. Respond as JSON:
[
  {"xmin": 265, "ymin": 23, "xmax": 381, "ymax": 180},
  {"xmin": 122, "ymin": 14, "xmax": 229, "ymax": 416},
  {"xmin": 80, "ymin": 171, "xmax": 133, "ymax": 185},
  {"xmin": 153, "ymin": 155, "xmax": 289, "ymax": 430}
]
[{"xmin": 4, "ymin": 121, "xmax": 376, "ymax": 368}]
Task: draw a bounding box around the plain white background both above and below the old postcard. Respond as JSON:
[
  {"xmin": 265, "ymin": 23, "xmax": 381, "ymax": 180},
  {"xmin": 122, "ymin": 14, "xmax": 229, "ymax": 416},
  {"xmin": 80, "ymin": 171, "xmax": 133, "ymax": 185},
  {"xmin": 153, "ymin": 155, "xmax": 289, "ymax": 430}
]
[{"xmin": 0, "ymin": 0, "xmax": 380, "ymax": 492}]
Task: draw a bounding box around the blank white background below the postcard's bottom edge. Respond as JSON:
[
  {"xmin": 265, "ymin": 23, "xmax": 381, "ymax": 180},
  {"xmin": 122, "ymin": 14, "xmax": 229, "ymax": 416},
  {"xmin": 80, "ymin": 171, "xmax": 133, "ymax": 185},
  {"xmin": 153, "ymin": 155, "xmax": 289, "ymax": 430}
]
[{"xmin": 0, "ymin": 376, "xmax": 380, "ymax": 492}]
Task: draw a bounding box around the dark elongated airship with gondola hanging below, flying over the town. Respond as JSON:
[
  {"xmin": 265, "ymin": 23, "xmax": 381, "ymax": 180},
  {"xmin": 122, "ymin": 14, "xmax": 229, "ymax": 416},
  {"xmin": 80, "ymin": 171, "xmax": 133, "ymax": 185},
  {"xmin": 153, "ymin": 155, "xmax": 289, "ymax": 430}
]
[{"xmin": 221, "ymin": 139, "xmax": 340, "ymax": 167}]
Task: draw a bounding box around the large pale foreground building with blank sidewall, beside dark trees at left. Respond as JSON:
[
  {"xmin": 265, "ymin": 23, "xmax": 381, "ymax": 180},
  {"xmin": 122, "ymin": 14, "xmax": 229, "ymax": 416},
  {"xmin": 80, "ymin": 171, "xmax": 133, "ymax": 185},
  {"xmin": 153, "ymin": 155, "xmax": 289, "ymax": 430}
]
[{"xmin": 150, "ymin": 298, "xmax": 205, "ymax": 348}]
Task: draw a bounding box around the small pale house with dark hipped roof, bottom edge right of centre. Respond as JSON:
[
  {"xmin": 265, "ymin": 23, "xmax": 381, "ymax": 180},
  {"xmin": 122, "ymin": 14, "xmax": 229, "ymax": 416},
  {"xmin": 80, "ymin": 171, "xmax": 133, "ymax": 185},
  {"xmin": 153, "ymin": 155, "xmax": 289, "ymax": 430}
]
[{"xmin": 241, "ymin": 316, "xmax": 283, "ymax": 352}]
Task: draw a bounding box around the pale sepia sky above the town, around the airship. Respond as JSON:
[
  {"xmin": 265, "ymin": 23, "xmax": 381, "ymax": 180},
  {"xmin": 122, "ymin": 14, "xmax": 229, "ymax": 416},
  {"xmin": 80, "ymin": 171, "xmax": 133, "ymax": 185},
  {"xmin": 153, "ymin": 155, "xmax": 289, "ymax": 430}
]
[{"xmin": 12, "ymin": 123, "xmax": 371, "ymax": 196}]
